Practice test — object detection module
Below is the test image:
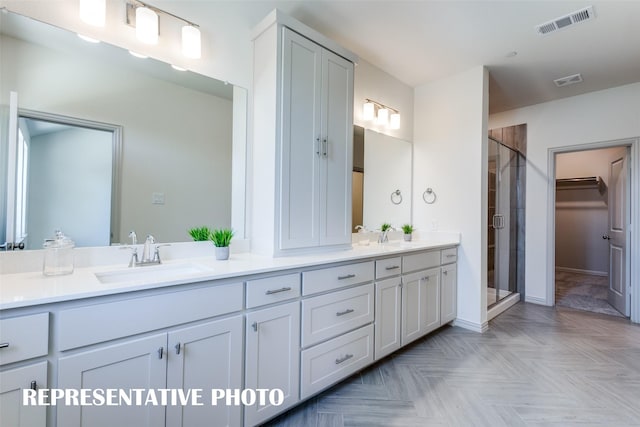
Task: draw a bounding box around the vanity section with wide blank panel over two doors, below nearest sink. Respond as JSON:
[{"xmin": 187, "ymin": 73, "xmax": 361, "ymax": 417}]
[{"xmin": 57, "ymin": 283, "xmax": 243, "ymax": 427}]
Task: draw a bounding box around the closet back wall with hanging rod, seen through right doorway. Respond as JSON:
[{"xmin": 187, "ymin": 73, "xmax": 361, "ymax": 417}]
[{"xmin": 556, "ymin": 148, "xmax": 618, "ymax": 274}]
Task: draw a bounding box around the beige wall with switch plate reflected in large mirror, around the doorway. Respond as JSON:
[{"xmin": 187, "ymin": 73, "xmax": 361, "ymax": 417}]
[{"xmin": 0, "ymin": 37, "xmax": 233, "ymax": 242}]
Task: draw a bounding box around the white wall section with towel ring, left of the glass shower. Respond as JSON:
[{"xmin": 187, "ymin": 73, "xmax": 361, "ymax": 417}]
[{"xmin": 413, "ymin": 67, "xmax": 488, "ymax": 330}]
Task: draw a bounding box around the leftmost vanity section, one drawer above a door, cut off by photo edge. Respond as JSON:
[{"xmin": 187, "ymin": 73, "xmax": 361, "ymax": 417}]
[{"xmin": 0, "ymin": 313, "xmax": 49, "ymax": 427}]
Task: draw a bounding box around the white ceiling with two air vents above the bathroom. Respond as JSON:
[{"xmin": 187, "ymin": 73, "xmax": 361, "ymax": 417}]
[{"xmin": 170, "ymin": 0, "xmax": 640, "ymax": 113}]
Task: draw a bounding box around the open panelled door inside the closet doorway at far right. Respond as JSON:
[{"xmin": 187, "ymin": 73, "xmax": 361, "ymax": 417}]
[{"xmin": 603, "ymin": 147, "xmax": 631, "ymax": 317}]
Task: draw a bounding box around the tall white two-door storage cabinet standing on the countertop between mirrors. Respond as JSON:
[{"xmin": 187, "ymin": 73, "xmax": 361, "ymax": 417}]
[{"xmin": 251, "ymin": 11, "xmax": 356, "ymax": 255}]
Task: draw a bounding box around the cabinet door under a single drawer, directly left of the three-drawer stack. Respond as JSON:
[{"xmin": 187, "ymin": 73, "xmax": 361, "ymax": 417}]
[{"xmin": 244, "ymin": 301, "xmax": 300, "ymax": 426}]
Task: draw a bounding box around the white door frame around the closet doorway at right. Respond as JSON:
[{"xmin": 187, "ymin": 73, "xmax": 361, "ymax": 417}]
[{"xmin": 546, "ymin": 138, "xmax": 640, "ymax": 323}]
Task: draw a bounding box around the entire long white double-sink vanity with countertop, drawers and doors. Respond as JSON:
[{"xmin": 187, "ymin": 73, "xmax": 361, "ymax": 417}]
[{"xmin": 0, "ymin": 238, "xmax": 459, "ymax": 426}]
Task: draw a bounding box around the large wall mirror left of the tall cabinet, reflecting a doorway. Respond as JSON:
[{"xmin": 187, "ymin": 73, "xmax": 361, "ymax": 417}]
[{"xmin": 0, "ymin": 12, "xmax": 247, "ymax": 249}]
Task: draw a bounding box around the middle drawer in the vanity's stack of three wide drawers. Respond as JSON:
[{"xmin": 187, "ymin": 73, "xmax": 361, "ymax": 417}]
[{"xmin": 302, "ymin": 283, "xmax": 374, "ymax": 347}]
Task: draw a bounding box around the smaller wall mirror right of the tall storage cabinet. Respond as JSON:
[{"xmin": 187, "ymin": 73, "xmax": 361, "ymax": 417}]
[{"xmin": 353, "ymin": 126, "xmax": 412, "ymax": 232}]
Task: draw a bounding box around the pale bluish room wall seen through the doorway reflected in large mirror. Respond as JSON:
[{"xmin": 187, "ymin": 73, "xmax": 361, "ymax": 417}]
[{"xmin": 27, "ymin": 128, "xmax": 112, "ymax": 249}]
